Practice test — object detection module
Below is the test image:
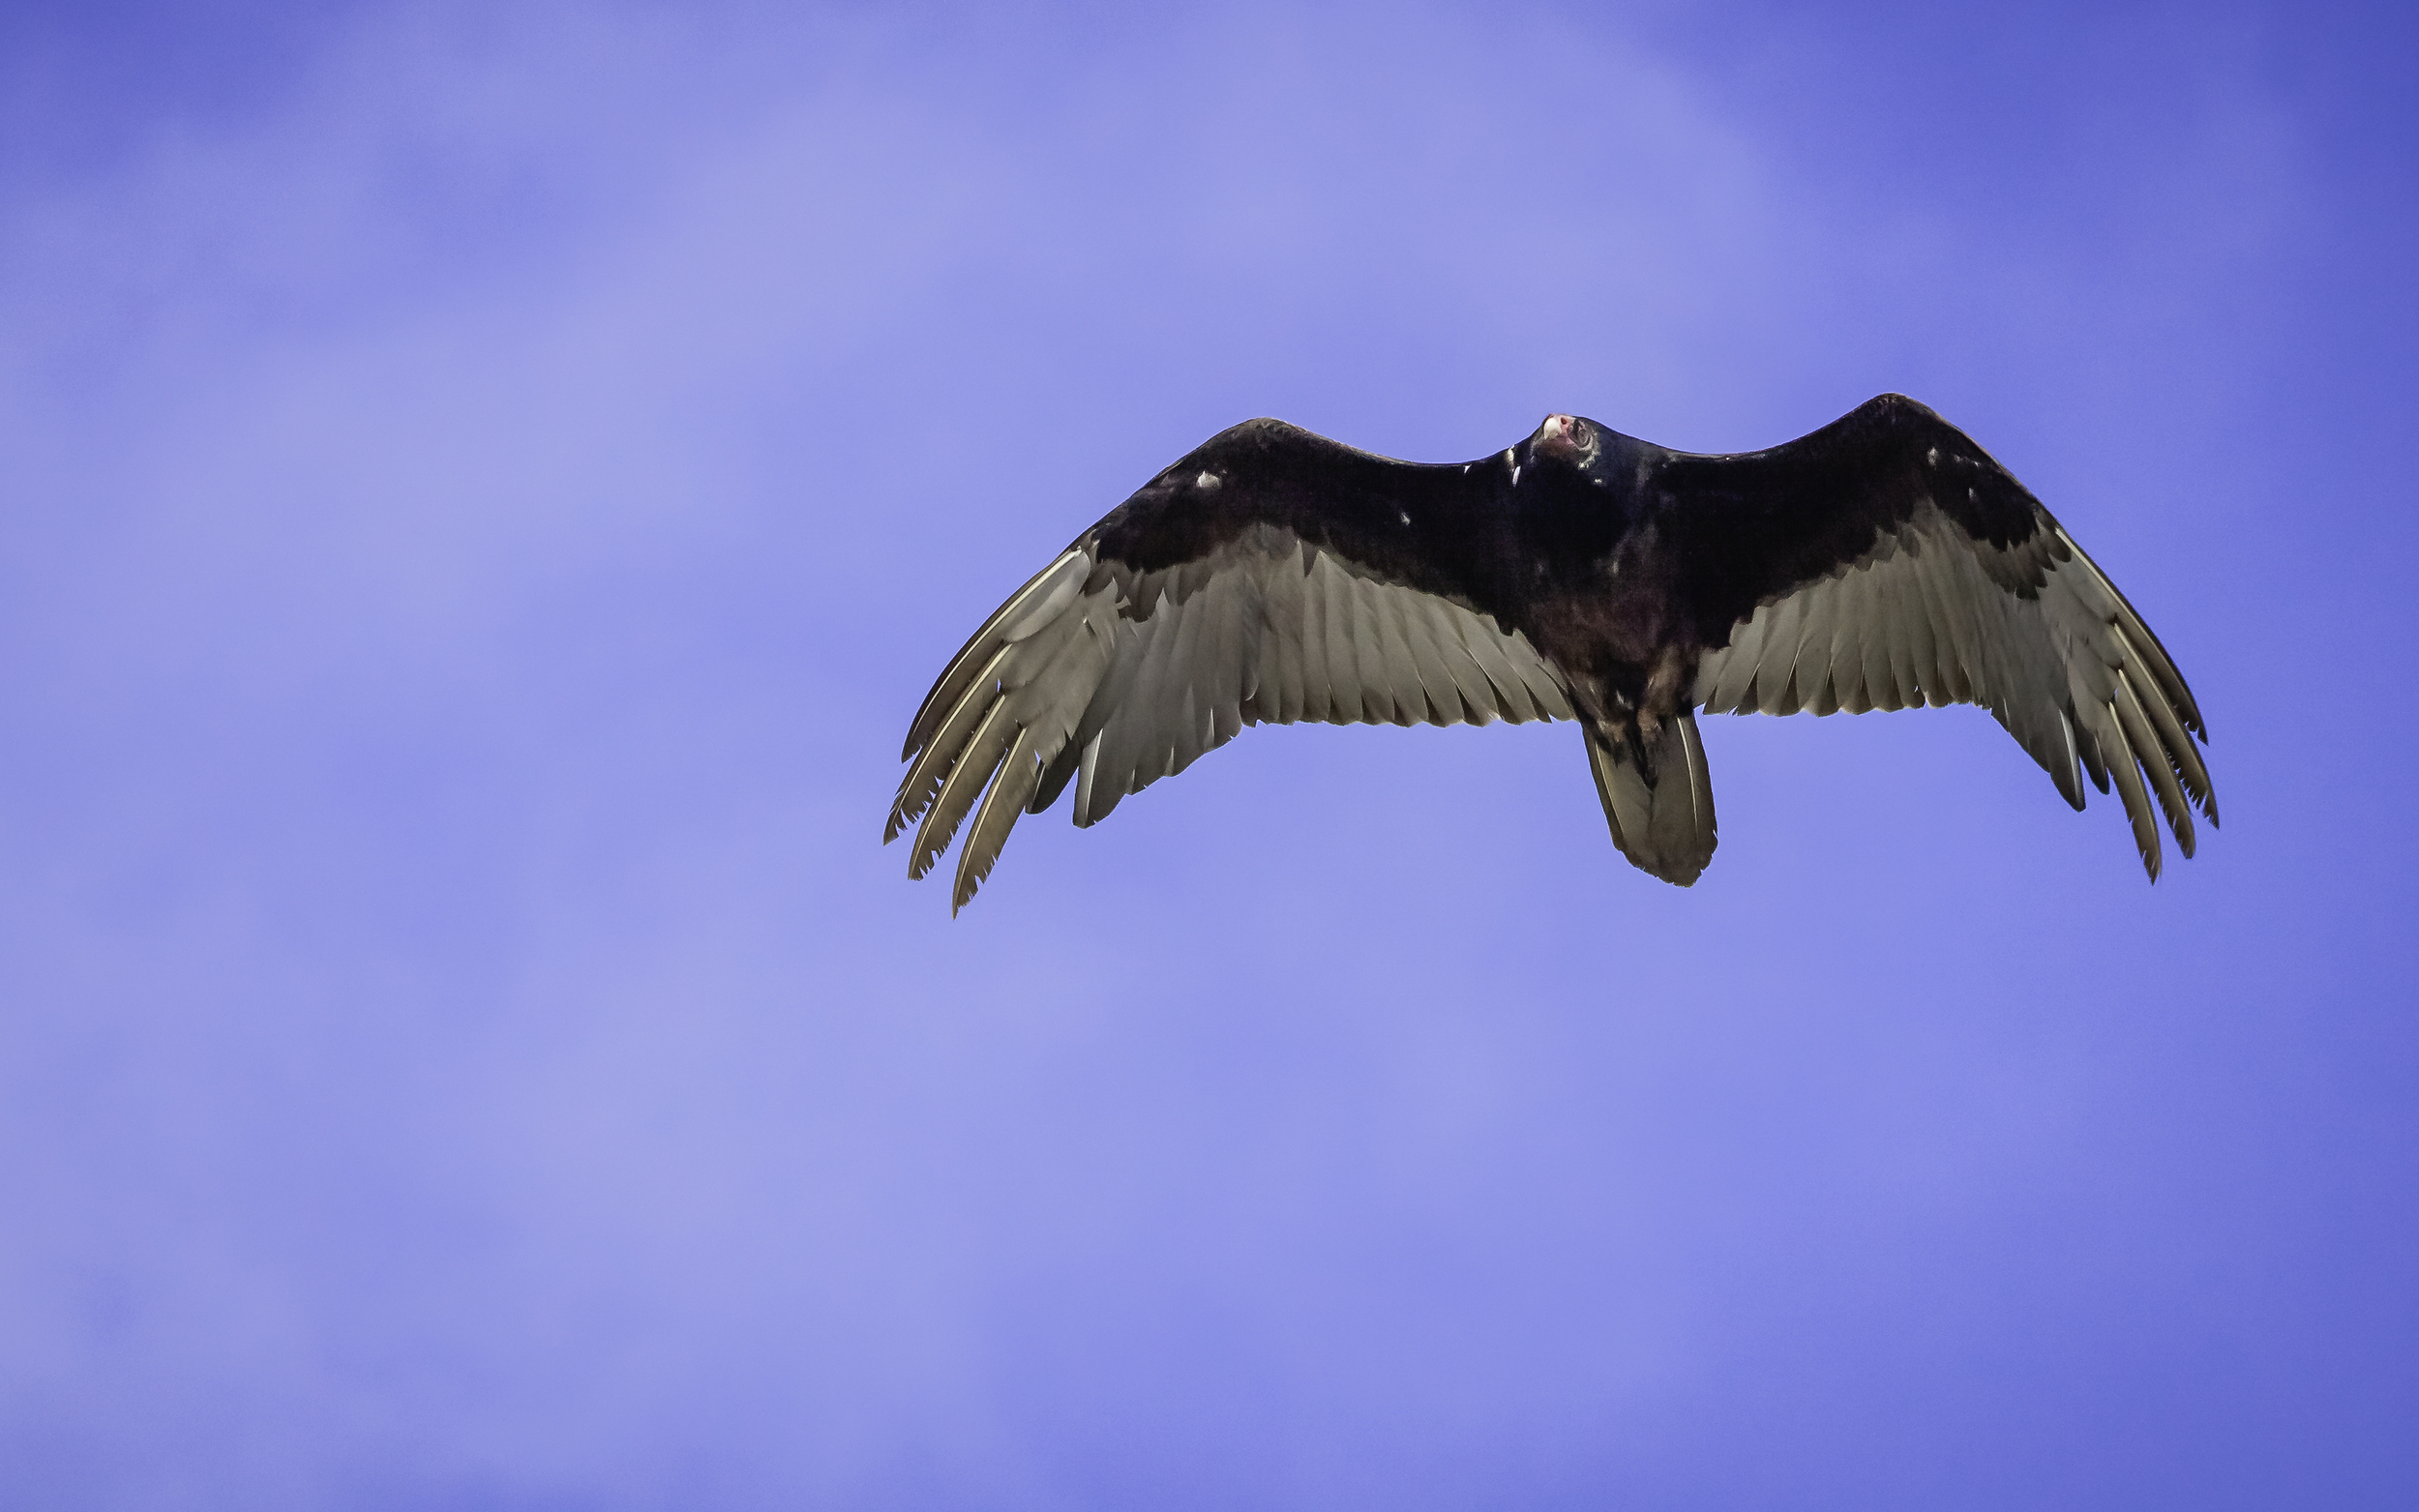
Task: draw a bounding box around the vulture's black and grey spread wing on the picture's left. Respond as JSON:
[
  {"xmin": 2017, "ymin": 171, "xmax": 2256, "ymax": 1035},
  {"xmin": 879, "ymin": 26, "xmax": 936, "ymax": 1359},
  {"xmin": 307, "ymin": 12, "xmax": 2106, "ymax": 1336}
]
[{"xmin": 883, "ymin": 421, "xmax": 1570, "ymax": 907}]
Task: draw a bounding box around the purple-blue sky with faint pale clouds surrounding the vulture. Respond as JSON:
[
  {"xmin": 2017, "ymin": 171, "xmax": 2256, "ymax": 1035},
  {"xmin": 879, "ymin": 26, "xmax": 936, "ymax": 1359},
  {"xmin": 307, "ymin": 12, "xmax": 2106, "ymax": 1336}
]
[{"xmin": 0, "ymin": 5, "xmax": 2419, "ymax": 1512}]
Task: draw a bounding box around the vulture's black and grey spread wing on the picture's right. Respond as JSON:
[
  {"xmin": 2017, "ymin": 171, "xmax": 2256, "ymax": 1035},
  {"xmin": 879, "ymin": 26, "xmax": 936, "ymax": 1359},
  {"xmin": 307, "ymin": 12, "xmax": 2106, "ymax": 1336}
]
[{"xmin": 1659, "ymin": 395, "xmax": 2219, "ymax": 880}]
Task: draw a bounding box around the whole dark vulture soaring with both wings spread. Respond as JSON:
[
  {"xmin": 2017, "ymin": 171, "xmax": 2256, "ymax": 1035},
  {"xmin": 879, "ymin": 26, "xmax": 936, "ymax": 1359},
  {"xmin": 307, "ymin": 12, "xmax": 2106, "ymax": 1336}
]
[{"xmin": 883, "ymin": 395, "xmax": 2219, "ymax": 912}]
